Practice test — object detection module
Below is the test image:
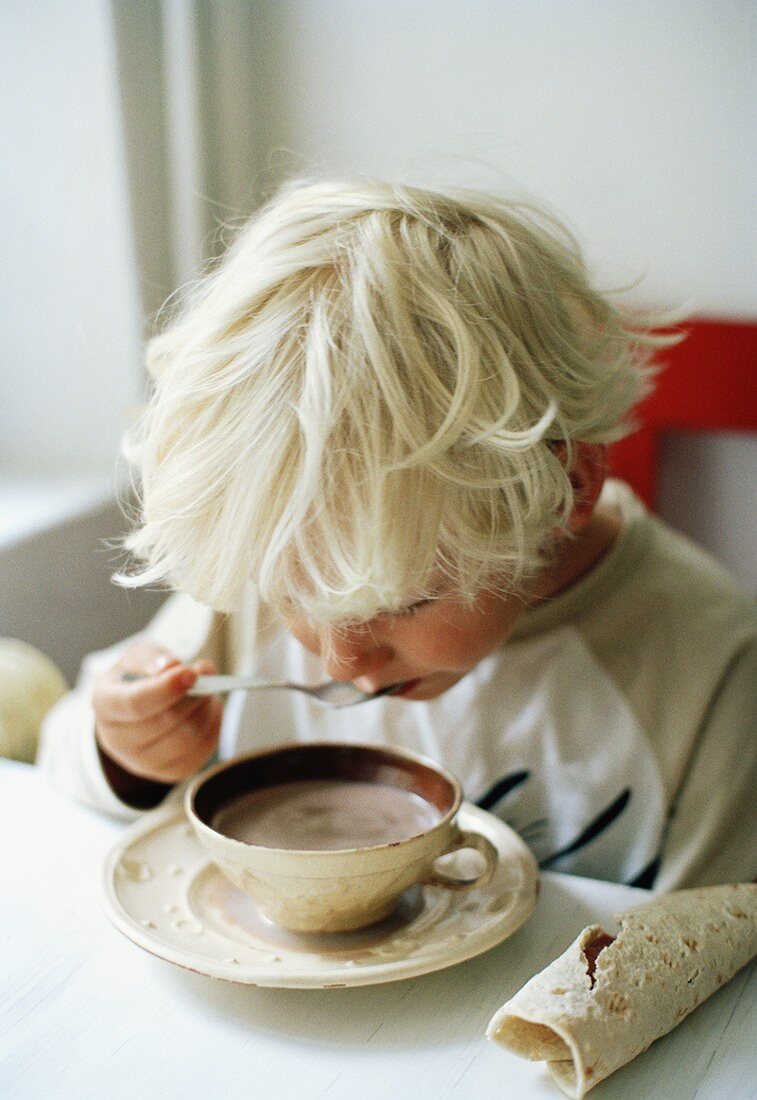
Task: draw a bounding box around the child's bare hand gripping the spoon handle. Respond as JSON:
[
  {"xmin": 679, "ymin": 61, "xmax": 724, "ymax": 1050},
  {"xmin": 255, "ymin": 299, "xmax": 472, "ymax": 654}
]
[{"xmin": 92, "ymin": 642, "xmax": 223, "ymax": 783}]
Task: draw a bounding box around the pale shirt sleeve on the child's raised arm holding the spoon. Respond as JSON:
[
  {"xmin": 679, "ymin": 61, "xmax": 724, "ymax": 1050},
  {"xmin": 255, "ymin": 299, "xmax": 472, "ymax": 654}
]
[{"xmin": 37, "ymin": 594, "xmax": 223, "ymax": 821}]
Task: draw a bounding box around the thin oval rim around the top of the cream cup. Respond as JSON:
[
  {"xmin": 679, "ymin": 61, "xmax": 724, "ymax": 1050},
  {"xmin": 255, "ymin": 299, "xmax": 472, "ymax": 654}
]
[{"xmin": 184, "ymin": 739, "xmax": 462, "ymax": 861}]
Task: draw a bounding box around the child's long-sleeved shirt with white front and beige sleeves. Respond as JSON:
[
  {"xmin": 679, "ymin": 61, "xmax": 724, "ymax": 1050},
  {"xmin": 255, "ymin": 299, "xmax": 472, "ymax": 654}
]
[{"xmin": 40, "ymin": 482, "xmax": 757, "ymax": 889}]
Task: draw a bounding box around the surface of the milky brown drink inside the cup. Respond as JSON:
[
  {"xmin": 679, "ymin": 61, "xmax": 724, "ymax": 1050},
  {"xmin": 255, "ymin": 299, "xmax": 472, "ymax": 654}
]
[{"xmin": 211, "ymin": 780, "xmax": 441, "ymax": 851}]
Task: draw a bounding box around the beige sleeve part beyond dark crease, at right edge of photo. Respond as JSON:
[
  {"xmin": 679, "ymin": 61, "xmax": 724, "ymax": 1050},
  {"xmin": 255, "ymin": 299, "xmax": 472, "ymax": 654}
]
[{"xmin": 654, "ymin": 641, "xmax": 757, "ymax": 891}]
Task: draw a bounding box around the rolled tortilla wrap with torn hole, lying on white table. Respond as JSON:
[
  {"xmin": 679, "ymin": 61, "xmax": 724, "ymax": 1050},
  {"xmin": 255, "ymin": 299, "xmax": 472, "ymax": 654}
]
[{"xmin": 486, "ymin": 883, "xmax": 757, "ymax": 1100}]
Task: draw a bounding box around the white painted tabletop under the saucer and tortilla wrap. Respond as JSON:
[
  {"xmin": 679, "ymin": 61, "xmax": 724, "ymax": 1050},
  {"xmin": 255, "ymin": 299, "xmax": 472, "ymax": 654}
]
[{"xmin": 0, "ymin": 761, "xmax": 757, "ymax": 1100}]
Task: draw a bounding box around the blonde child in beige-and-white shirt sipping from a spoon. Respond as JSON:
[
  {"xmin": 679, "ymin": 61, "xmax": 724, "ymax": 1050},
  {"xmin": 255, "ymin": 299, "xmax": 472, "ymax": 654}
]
[{"xmin": 41, "ymin": 176, "xmax": 757, "ymax": 889}]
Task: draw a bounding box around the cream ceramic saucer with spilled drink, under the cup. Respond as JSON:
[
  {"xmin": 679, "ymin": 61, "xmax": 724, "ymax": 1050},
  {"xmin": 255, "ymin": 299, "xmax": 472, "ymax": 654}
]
[{"xmin": 103, "ymin": 803, "xmax": 538, "ymax": 989}]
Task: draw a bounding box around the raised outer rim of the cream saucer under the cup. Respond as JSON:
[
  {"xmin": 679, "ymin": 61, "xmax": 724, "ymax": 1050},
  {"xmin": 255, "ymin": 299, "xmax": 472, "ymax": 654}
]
[{"xmin": 100, "ymin": 802, "xmax": 539, "ymax": 989}]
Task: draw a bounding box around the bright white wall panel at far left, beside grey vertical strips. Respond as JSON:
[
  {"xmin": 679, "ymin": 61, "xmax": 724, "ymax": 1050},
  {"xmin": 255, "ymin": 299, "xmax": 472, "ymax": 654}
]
[{"xmin": 0, "ymin": 0, "xmax": 142, "ymax": 476}]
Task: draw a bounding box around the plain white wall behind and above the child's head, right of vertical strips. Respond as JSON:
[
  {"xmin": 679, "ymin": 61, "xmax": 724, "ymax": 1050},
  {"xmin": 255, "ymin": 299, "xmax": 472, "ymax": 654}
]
[{"xmin": 249, "ymin": 0, "xmax": 757, "ymax": 316}]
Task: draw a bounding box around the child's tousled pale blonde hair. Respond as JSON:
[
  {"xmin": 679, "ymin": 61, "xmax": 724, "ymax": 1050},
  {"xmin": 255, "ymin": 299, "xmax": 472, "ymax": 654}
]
[{"xmin": 120, "ymin": 182, "xmax": 671, "ymax": 622}]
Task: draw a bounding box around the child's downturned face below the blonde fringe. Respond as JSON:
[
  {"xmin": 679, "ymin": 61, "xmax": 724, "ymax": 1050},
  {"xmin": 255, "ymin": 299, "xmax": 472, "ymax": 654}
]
[{"xmin": 285, "ymin": 592, "xmax": 525, "ymax": 700}]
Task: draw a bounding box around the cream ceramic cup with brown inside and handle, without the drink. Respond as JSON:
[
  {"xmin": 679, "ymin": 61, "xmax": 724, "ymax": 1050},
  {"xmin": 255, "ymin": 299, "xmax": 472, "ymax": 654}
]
[{"xmin": 185, "ymin": 741, "xmax": 497, "ymax": 933}]
